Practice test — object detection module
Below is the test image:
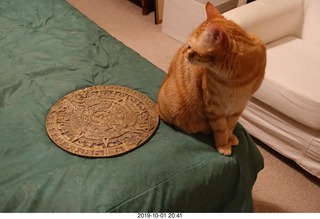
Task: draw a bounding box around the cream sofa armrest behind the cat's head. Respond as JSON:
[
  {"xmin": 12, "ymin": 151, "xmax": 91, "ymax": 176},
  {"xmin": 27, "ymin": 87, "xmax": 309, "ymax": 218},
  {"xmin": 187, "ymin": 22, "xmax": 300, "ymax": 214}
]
[{"xmin": 223, "ymin": 0, "xmax": 304, "ymax": 44}]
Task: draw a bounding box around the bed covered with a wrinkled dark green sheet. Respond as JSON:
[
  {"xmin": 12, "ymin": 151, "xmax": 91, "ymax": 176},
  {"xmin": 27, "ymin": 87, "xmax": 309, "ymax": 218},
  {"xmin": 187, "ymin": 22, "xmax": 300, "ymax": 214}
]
[{"xmin": 0, "ymin": 0, "xmax": 263, "ymax": 212}]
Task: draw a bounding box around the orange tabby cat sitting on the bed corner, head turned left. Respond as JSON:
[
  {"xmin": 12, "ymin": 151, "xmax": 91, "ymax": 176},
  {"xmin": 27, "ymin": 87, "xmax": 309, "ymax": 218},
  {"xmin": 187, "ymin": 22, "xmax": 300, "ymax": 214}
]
[{"xmin": 157, "ymin": 3, "xmax": 266, "ymax": 155}]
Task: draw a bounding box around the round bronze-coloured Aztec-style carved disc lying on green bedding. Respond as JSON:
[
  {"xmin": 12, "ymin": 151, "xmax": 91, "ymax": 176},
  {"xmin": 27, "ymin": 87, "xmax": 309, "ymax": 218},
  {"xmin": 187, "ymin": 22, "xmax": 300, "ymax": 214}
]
[{"xmin": 46, "ymin": 85, "xmax": 159, "ymax": 157}]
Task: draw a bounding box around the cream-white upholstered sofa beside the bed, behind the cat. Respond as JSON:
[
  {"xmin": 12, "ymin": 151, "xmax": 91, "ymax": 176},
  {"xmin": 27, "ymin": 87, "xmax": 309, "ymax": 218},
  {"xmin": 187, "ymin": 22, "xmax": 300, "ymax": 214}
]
[{"xmin": 224, "ymin": 0, "xmax": 320, "ymax": 178}]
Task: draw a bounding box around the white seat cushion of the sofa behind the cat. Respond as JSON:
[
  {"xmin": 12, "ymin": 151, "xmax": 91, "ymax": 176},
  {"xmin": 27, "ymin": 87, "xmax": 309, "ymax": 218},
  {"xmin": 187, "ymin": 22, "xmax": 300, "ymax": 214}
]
[{"xmin": 254, "ymin": 37, "xmax": 320, "ymax": 129}]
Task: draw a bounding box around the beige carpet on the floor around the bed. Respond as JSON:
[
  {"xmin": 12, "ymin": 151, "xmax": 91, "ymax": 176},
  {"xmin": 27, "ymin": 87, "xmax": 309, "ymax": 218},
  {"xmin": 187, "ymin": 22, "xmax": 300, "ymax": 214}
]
[{"xmin": 68, "ymin": 0, "xmax": 320, "ymax": 212}]
